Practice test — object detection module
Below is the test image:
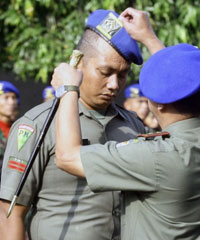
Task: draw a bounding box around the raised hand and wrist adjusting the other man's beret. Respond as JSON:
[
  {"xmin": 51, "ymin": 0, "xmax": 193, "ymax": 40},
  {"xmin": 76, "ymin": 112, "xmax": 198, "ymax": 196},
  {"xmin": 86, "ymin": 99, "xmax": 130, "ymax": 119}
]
[{"xmin": 120, "ymin": 8, "xmax": 165, "ymax": 54}]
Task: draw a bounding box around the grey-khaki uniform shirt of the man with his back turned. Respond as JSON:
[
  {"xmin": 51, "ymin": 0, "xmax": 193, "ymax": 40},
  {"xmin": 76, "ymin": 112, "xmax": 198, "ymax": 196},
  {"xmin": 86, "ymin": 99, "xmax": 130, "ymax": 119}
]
[{"xmin": 81, "ymin": 118, "xmax": 200, "ymax": 240}]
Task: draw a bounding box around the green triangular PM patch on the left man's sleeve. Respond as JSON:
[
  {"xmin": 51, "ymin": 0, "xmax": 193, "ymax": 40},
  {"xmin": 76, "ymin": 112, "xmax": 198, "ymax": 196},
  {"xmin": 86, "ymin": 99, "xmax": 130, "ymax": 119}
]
[{"xmin": 17, "ymin": 124, "xmax": 34, "ymax": 151}]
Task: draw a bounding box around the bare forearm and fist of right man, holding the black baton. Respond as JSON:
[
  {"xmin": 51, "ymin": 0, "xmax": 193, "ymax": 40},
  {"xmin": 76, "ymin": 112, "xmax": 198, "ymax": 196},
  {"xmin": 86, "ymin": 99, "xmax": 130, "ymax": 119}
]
[{"xmin": 51, "ymin": 63, "xmax": 85, "ymax": 177}]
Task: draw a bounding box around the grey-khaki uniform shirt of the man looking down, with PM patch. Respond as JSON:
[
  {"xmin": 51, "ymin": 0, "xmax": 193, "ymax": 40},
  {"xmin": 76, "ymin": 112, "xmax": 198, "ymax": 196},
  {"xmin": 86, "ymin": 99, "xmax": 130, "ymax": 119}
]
[{"xmin": 0, "ymin": 98, "xmax": 144, "ymax": 240}]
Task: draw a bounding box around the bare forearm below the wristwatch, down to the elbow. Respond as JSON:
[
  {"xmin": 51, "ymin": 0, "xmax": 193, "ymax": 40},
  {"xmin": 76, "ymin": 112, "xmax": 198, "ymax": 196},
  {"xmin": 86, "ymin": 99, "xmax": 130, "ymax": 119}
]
[{"xmin": 56, "ymin": 92, "xmax": 84, "ymax": 177}]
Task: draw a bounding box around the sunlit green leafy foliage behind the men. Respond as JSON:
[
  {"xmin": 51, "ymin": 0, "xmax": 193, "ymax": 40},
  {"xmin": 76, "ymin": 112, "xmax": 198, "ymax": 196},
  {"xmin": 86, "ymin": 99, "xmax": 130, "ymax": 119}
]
[{"xmin": 0, "ymin": 0, "xmax": 200, "ymax": 83}]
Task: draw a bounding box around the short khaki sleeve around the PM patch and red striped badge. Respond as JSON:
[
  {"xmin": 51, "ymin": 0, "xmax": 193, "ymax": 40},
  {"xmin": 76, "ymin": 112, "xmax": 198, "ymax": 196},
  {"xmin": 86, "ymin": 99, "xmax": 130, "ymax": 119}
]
[{"xmin": 0, "ymin": 117, "xmax": 48, "ymax": 206}]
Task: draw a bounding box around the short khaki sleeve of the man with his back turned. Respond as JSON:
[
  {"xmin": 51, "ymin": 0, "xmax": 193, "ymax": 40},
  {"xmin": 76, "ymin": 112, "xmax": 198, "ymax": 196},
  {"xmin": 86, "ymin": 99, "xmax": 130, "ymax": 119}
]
[{"xmin": 81, "ymin": 140, "xmax": 157, "ymax": 192}]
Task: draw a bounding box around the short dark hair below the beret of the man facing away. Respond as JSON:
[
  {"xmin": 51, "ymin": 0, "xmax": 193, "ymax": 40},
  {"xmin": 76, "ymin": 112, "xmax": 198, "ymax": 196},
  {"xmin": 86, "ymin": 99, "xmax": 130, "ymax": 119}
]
[{"xmin": 172, "ymin": 90, "xmax": 200, "ymax": 116}]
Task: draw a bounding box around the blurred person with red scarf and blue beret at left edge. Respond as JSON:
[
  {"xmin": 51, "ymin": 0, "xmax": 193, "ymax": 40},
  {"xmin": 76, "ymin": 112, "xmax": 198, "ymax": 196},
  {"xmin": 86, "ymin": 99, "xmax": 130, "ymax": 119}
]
[{"xmin": 0, "ymin": 81, "xmax": 19, "ymax": 181}]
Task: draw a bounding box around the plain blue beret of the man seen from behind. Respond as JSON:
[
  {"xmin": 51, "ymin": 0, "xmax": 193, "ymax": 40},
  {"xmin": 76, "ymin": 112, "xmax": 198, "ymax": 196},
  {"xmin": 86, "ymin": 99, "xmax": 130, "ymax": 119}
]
[{"xmin": 139, "ymin": 43, "xmax": 200, "ymax": 104}]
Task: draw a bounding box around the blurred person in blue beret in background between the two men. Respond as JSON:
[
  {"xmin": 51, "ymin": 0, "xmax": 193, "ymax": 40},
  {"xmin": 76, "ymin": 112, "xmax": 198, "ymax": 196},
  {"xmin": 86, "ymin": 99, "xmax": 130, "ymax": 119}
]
[{"xmin": 123, "ymin": 83, "xmax": 160, "ymax": 132}]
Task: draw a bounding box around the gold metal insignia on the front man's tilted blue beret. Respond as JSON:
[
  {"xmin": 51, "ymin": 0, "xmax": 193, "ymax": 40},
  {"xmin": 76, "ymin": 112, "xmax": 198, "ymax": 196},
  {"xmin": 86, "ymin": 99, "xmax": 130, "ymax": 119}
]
[{"xmin": 97, "ymin": 13, "xmax": 122, "ymax": 39}]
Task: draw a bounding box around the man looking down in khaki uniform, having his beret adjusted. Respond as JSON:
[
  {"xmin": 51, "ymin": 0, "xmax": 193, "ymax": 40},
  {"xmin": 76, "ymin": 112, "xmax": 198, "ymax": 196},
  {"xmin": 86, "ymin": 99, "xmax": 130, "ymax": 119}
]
[{"xmin": 0, "ymin": 7, "xmax": 160, "ymax": 240}]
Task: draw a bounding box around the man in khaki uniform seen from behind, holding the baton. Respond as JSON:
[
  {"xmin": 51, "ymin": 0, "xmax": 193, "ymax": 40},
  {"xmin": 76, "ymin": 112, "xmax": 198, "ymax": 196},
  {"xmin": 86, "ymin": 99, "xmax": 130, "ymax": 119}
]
[{"xmin": 48, "ymin": 9, "xmax": 200, "ymax": 240}]
